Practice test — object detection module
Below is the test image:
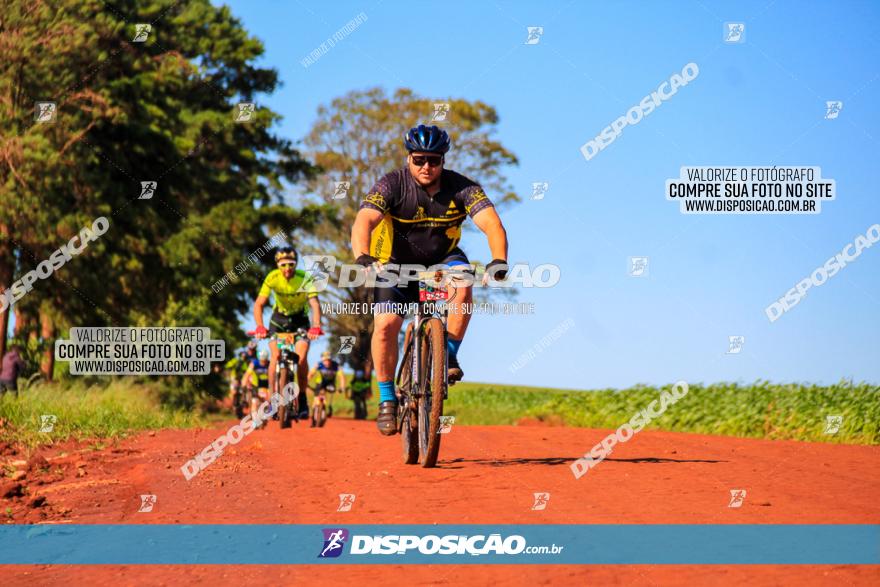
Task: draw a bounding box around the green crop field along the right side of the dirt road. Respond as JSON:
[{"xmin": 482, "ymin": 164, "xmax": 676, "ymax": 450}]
[{"xmin": 444, "ymin": 381, "xmax": 880, "ymax": 444}]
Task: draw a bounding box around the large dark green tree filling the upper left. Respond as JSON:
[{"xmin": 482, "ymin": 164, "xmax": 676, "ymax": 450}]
[{"xmin": 0, "ymin": 0, "xmax": 327, "ymax": 392}]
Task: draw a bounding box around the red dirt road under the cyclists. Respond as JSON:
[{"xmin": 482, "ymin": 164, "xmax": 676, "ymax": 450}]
[{"xmin": 0, "ymin": 418, "xmax": 880, "ymax": 586}]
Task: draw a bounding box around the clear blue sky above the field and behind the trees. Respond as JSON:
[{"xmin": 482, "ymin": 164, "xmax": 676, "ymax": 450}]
[{"xmin": 220, "ymin": 0, "xmax": 880, "ymax": 389}]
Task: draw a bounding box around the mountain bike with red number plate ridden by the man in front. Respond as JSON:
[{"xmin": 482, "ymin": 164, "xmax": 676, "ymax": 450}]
[{"xmin": 397, "ymin": 271, "xmax": 448, "ymax": 468}]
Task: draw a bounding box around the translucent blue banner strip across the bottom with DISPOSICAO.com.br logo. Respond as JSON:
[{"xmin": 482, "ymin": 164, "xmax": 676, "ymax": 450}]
[{"xmin": 0, "ymin": 524, "xmax": 880, "ymax": 565}]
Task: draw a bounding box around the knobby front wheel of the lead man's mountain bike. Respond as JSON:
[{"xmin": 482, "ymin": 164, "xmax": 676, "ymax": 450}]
[{"xmin": 418, "ymin": 318, "xmax": 447, "ymax": 468}]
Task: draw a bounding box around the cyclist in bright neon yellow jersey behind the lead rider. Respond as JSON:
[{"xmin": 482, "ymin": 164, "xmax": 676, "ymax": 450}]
[{"xmin": 254, "ymin": 247, "xmax": 324, "ymax": 419}]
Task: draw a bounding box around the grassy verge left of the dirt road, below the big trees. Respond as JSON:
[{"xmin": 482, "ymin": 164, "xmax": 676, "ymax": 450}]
[{"xmin": 0, "ymin": 379, "xmax": 204, "ymax": 448}]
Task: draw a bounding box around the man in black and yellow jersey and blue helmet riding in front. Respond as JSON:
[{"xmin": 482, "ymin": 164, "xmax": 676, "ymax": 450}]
[{"xmin": 351, "ymin": 125, "xmax": 507, "ymax": 436}]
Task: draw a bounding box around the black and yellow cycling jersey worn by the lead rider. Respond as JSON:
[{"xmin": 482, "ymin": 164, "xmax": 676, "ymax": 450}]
[{"xmin": 360, "ymin": 167, "xmax": 493, "ymax": 265}]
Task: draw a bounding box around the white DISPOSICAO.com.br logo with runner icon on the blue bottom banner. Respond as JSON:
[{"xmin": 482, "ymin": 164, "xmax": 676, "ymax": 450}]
[{"xmin": 318, "ymin": 528, "xmax": 565, "ymax": 558}]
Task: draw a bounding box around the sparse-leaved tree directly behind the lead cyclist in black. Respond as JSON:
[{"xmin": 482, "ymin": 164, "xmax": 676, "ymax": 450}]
[{"xmin": 304, "ymin": 88, "xmax": 519, "ymax": 367}]
